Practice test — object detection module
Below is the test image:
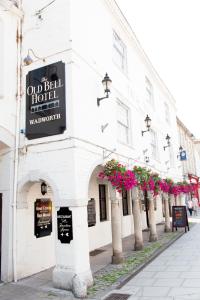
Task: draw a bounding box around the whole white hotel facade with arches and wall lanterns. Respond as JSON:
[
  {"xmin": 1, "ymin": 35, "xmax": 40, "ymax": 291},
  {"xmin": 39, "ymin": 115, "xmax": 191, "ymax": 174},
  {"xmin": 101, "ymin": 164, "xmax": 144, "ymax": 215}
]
[{"xmin": 0, "ymin": 0, "xmax": 182, "ymax": 296}]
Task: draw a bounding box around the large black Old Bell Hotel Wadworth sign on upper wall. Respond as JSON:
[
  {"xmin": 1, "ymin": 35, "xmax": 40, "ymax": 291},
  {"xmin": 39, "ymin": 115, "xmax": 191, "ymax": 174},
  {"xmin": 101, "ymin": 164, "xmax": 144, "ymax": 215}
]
[{"xmin": 26, "ymin": 61, "xmax": 66, "ymax": 140}]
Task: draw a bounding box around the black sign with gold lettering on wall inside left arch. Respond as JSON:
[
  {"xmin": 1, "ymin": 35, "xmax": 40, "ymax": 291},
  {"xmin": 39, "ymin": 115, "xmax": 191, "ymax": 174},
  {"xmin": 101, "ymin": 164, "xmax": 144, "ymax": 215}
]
[{"xmin": 34, "ymin": 199, "xmax": 52, "ymax": 238}]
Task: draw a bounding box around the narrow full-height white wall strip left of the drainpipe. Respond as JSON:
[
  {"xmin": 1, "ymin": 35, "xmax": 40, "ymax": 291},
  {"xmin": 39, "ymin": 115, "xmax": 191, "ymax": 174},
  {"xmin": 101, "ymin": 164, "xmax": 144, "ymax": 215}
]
[{"xmin": 0, "ymin": 1, "xmax": 19, "ymax": 282}]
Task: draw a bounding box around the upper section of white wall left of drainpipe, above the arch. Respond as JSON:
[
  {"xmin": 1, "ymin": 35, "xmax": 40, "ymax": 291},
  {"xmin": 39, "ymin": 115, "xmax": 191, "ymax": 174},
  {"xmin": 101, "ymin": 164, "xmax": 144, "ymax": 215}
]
[{"xmin": 0, "ymin": 10, "xmax": 18, "ymax": 135}]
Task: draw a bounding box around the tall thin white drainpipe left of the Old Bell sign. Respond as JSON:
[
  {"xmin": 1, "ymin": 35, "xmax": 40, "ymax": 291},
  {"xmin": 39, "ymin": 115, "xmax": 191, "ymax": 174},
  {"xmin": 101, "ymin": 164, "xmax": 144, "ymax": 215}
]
[{"xmin": 12, "ymin": 0, "xmax": 22, "ymax": 282}]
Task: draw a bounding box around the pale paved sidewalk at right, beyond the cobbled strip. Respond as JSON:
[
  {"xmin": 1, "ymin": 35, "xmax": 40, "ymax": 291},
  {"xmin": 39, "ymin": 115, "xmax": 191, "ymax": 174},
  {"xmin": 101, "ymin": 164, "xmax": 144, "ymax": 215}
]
[{"xmin": 104, "ymin": 217, "xmax": 200, "ymax": 300}]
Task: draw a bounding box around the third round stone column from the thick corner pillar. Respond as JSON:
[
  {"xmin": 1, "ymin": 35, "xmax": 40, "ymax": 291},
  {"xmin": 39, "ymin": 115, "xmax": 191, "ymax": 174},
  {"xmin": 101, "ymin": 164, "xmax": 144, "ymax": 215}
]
[{"xmin": 147, "ymin": 191, "xmax": 158, "ymax": 242}]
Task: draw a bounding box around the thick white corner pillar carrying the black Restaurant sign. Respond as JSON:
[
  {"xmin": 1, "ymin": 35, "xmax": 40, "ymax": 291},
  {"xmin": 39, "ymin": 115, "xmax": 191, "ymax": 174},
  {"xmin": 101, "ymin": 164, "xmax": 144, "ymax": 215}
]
[{"xmin": 53, "ymin": 201, "xmax": 93, "ymax": 298}]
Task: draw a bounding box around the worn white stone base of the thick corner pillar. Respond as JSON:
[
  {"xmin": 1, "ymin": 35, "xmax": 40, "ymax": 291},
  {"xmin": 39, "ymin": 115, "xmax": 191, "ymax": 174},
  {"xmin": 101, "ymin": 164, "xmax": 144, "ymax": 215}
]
[{"xmin": 53, "ymin": 267, "xmax": 93, "ymax": 298}]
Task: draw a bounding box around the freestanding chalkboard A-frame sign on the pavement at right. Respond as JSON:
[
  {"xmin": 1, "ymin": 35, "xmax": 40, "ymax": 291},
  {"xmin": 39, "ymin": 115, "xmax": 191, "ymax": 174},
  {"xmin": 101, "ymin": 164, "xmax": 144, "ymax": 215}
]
[{"xmin": 172, "ymin": 206, "xmax": 189, "ymax": 231}]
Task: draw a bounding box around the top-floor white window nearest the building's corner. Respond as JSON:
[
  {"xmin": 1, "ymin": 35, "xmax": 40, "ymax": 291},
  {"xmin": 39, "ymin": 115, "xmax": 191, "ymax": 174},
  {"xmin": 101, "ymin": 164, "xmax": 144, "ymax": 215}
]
[{"xmin": 113, "ymin": 31, "xmax": 127, "ymax": 72}]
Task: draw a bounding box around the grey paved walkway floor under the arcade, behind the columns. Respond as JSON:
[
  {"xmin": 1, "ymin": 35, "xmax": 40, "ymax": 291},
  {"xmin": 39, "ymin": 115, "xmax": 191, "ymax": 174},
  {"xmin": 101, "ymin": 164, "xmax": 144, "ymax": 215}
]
[{"xmin": 0, "ymin": 224, "xmax": 164, "ymax": 300}]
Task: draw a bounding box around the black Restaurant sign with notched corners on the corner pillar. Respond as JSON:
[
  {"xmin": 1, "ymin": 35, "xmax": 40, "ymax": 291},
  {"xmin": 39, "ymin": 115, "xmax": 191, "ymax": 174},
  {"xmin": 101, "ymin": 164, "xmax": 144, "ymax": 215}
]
[{"xmin": 57, "ymin": 207, "xmax": 73, "ymax": 244}]
